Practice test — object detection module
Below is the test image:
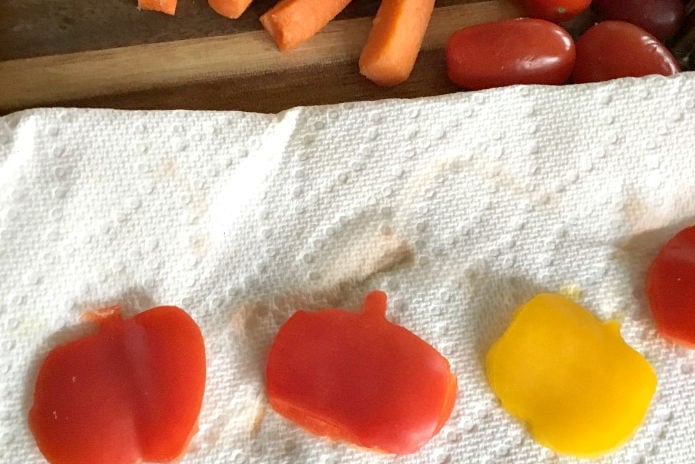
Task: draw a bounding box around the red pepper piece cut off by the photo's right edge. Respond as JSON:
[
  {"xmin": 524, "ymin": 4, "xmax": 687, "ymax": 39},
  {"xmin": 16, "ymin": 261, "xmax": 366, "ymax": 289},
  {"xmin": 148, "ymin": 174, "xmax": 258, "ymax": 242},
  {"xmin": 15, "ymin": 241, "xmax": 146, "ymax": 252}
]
[{"xmin": 647, "ymin": 226, "xmax": 695, "ymax": 348}]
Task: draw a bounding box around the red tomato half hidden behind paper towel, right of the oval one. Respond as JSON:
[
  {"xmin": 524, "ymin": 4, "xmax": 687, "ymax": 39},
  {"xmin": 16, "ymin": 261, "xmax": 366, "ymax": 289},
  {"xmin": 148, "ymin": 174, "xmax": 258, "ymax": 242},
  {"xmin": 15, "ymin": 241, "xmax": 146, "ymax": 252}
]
[{"xmin": 572, "ymin": 21, "xmax": 680, "ymax": 83}]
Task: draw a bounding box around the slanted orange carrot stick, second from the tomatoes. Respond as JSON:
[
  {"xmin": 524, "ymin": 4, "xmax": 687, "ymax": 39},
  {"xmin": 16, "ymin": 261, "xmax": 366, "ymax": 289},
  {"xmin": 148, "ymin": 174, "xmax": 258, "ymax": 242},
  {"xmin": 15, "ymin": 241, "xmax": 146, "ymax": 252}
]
[{"xmin": 260, "ymin": 0, "xmax": 350, "ymax": 51}]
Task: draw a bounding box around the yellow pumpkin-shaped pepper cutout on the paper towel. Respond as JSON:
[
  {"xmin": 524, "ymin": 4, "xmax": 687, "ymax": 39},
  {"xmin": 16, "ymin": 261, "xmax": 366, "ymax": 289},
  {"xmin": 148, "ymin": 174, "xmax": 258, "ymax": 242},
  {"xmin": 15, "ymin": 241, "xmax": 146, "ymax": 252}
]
[{"xmin": 485, "ymin": 293, "xmax": 656, "ymax": 457}]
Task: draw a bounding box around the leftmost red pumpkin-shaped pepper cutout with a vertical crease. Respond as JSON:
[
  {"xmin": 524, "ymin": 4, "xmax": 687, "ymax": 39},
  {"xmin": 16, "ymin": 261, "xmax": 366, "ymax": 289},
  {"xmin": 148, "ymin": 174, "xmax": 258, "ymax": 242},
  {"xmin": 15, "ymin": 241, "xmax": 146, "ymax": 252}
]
[{"xmin": 29, "ymin": 306, "xmax": 205, "ymax": 464}]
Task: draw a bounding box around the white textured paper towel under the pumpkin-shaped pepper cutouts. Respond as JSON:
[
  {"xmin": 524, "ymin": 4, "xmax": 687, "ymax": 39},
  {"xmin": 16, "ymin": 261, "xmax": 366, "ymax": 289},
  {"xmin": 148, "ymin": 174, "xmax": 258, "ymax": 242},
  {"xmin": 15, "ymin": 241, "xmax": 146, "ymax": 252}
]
[{"xmin": 0, "ymin": 74, "xmax": 695, "ymax": 464}]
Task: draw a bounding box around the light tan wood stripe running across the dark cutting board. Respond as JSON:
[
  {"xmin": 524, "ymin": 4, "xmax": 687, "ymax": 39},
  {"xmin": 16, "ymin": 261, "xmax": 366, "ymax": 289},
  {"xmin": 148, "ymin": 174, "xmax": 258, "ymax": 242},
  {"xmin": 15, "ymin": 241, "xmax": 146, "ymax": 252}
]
[{"xmin": 0, "ymin": 0, "xmax": 521, "ymax": 113}]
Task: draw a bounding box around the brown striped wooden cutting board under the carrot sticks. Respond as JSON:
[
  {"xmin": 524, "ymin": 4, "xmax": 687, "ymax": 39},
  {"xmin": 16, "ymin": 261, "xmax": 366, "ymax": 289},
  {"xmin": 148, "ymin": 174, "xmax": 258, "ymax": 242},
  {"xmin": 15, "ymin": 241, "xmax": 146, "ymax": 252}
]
[{"xmin": 0, "ymin": 0, "xmax": 521, "ymax": 113}]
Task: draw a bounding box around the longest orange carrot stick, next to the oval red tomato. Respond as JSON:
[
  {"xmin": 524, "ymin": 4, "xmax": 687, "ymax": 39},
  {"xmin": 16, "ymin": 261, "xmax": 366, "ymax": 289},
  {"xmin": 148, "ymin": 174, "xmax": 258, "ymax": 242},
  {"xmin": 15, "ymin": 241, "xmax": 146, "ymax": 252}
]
[{"xmin": 359, "ymin": 0, "xmax": 434, "ymax": 86}]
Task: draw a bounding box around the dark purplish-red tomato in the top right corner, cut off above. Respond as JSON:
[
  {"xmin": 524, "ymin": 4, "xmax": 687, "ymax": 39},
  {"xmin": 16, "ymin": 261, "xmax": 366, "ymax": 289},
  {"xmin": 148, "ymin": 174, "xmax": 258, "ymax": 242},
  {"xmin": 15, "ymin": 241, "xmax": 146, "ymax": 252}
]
[{"xmin": 592, "ymin": 0, "xmax": 685, "ymax": 42}]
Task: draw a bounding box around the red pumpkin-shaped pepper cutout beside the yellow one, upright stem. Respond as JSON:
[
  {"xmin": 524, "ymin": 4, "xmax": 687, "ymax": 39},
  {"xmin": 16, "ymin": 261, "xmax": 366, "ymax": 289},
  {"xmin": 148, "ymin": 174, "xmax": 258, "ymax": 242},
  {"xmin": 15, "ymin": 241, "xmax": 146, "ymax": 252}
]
[{"xmin": 266, "ymin": 291, "xmax": 457, "ymax": 454}]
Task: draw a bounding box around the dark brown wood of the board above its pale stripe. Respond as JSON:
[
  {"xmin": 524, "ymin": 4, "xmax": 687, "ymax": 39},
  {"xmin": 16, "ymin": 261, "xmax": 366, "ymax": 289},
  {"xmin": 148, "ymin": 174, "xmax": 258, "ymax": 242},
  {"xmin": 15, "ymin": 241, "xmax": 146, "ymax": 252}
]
[{"xmin": 0, "ymin": 0, "xmax": 386, "ymax": 60}]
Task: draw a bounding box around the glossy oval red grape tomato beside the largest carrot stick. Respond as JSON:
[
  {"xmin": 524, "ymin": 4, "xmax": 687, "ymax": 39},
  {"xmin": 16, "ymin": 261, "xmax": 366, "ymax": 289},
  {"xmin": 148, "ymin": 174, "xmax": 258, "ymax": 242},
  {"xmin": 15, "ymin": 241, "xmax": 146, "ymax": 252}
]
[{"xmin": 446, "ymin": 18, "xmax": 575, "ymax": 90}]
